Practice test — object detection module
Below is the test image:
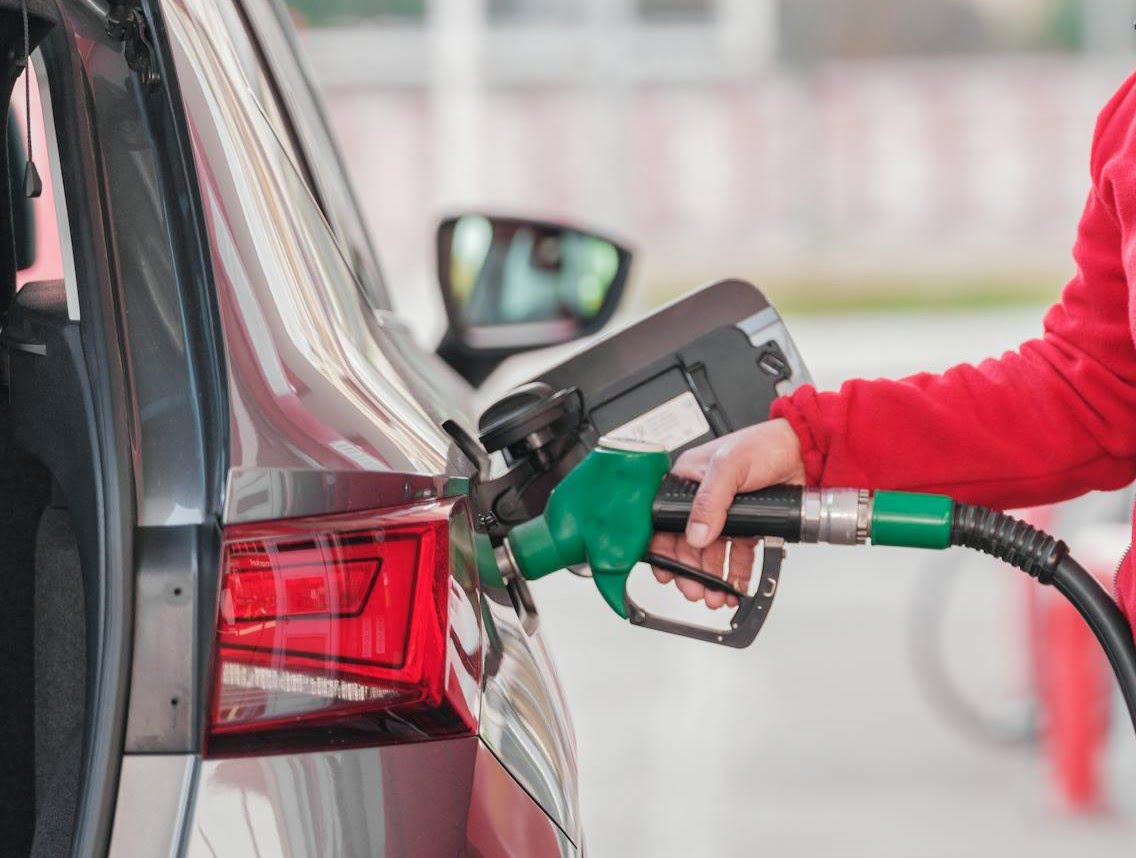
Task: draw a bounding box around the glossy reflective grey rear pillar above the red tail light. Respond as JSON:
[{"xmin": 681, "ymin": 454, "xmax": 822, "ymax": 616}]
[{"xmin": 164, "ymin": 0, "xmax": 453, "ymax": 474}]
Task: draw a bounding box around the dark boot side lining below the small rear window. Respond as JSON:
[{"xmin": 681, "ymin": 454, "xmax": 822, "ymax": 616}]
[{"xmin": 0, "ymin": 281, "xmax": 90, "ymax": 855}]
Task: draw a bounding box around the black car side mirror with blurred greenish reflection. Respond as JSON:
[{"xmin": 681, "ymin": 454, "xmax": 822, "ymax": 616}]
[{"xmin": 437, "ymin": 214, "xmax": 632, "ymax": 386}]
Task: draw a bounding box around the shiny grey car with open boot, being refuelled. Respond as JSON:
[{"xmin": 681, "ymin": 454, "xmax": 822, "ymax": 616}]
[{"xmin": 0, "ymin": 0, "xmax": 628, "ymax": 858}]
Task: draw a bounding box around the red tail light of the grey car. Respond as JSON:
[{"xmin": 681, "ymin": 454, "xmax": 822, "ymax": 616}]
[{"xmin": 207, "ymin": 501, "xmax": 481, "ymax": 756}]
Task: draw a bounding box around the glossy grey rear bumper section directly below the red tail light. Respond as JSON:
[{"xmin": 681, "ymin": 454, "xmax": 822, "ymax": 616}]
[{"xmin": 170, "ymin": 739, "xmax": 576, "ymax": 858}]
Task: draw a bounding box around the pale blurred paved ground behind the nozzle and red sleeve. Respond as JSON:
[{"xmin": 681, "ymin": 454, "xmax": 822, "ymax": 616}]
[{"xmin": 535, "ymin": 311, "xmax": 1136, "ymax": 858}]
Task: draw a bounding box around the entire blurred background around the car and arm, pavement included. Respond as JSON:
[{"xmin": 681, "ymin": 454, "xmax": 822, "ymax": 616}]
[{"xmin": 284, "ymin": 0, "xmax": 1136, "ymax": 858}]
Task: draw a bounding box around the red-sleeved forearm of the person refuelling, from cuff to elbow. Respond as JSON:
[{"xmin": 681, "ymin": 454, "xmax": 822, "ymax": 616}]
[{"xmin": 774, "ymin": 356, "xmax": 1136, "ymax": 508}]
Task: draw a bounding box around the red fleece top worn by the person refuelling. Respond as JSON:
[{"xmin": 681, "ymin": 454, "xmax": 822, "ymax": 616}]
[{"xmin": 772, "ymin": 75, "xmax": 1136, "ymax": 625}]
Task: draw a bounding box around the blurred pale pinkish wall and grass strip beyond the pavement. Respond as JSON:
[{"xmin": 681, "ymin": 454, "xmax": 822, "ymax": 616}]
[{"xmin": 286, "ymin": 0, "xmax": 1136, "ymax": 336}]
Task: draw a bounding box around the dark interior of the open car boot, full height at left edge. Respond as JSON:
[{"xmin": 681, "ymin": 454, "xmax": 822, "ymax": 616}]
[{"xmin": 0, "ymin": 1, "xmax": 89, "ymax": 856}]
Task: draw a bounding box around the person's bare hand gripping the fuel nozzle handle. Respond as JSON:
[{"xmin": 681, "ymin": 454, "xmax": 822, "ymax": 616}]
[{"xmin": 648, "ymin": 419, "xmax": 804, "ymax": 608}]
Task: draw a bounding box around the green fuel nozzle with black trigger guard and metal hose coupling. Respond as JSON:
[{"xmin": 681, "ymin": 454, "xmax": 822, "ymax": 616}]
[{"xmin": 498, "ymin": 438, "xmax": 953, "ymax": 647}]
